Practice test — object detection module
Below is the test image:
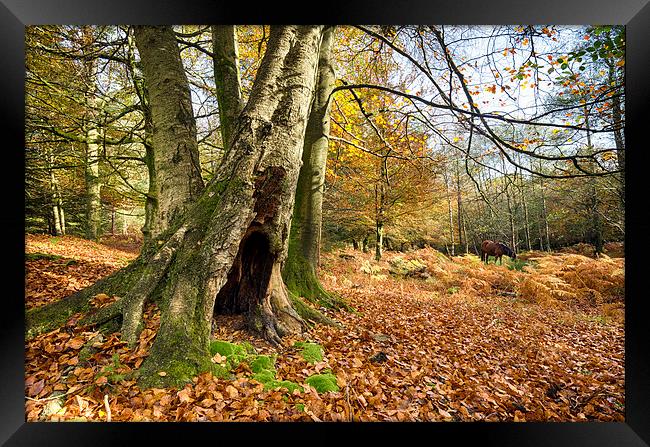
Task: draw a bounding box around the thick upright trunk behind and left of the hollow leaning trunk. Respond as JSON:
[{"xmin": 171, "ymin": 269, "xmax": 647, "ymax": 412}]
[{"xmin": 133, "ymin": 26, "xmax": 203, "ymax": 238}]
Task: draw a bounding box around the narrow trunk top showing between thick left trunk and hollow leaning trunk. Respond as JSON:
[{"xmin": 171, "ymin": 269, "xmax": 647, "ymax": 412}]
[{"xmin": 212, "ymin": 25, "xmax": 244, "ymax": 153}]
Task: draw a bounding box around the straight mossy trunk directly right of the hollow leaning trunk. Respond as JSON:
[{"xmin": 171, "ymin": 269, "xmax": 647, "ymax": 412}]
[{"xmin": 282, "ymin": 27, "xmax": 337, "ymax": 307}]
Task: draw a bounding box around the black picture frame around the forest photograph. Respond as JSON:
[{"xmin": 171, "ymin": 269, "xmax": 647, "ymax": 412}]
[{"xmin": 0, "ymin": 0, "xmax": 650, "ymax": 446}]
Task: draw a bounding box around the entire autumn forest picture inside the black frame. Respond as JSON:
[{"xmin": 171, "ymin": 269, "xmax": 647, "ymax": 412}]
[{"xmin": 24, "ymin": 25, "xmax": 625, "ymax": 422}]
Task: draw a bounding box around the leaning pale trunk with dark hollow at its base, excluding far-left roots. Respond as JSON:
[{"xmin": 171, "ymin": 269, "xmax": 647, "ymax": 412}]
[{"xmin": 133, "ymin": 26, "xmax": 322, "ymax": 386}]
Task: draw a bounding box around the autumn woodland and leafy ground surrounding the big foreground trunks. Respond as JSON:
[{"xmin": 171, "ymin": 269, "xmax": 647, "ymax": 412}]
[{"xmin": 25, "ymin": 25, "xmax": 625, "ymax": 421}]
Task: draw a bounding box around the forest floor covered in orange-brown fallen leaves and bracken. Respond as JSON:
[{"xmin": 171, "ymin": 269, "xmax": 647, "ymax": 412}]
[{"xmin": 25, "ymin": 235, "xmax": 625, "ymax": 421}]
